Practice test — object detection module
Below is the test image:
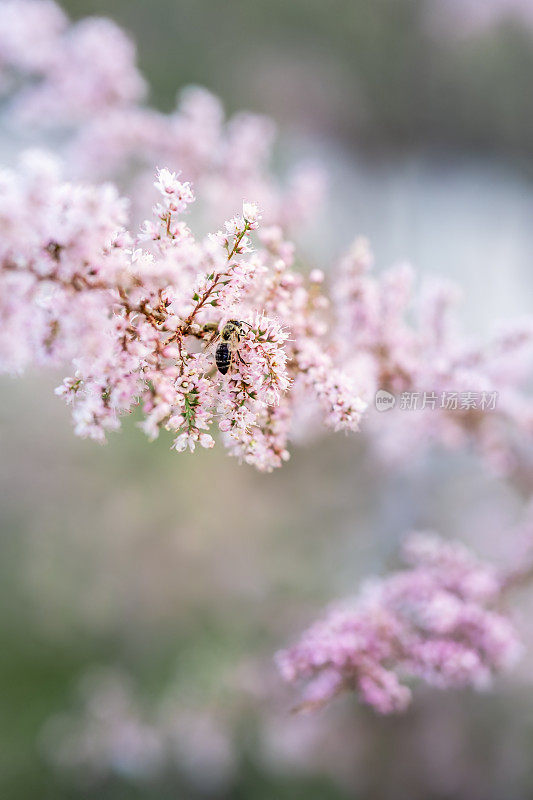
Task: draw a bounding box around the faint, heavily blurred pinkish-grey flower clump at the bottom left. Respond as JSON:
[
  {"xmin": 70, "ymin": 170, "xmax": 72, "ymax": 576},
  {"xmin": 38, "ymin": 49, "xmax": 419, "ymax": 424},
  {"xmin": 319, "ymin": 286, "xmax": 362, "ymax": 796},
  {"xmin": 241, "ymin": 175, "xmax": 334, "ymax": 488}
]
[{"xmin": 41, "ymin": 668, "xmax": 237, "ymax": 790}]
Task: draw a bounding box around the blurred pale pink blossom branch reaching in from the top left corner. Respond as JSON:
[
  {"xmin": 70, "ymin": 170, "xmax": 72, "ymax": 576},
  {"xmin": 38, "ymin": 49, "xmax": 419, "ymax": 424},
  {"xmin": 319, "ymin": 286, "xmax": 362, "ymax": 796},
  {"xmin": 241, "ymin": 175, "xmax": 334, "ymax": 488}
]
[{"xmin": 0, "ymin": 0, "xmax": 324, "ymax": 230}]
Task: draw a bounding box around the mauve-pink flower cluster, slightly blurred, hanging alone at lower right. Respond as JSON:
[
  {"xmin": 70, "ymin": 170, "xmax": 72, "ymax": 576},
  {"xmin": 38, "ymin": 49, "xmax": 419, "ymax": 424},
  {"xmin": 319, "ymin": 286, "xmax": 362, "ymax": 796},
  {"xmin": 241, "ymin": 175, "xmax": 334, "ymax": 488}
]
[{"xmin": 278, "ymin": 534, "xmax": 520, "ymax": 714}]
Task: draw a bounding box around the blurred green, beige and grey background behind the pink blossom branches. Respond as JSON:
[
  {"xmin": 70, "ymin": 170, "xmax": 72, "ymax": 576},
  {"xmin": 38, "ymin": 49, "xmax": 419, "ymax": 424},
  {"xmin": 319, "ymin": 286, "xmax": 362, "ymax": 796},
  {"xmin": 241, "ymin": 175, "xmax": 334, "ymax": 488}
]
[{"xmin": 0, "ymin": 0, "xmax": 533, "ymax": 800}]
